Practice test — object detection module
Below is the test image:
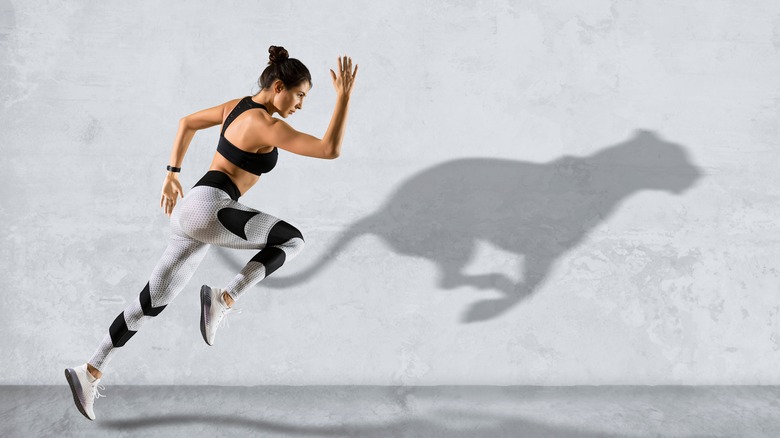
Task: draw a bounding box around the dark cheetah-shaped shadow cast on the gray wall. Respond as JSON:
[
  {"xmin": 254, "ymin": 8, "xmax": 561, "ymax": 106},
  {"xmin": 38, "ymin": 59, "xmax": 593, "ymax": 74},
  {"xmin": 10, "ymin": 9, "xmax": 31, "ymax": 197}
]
[{"xmin": 215, "ymin": 130, "xmax": 701, "ymax": 322}]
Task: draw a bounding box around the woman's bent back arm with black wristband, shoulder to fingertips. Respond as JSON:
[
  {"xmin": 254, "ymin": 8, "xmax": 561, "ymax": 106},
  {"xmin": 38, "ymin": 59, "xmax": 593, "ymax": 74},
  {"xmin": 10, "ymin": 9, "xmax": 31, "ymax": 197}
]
[{"xmin": 160, "ymin": 100, "xmax": 235, "ymax": 216}]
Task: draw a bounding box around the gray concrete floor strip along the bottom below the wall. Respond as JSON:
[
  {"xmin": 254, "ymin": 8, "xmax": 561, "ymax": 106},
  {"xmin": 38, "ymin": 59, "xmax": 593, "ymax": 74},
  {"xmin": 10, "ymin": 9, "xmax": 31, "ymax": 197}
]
[{"xmin": 0, "ymin": 382, "xmax": 780, "ymax": 438}]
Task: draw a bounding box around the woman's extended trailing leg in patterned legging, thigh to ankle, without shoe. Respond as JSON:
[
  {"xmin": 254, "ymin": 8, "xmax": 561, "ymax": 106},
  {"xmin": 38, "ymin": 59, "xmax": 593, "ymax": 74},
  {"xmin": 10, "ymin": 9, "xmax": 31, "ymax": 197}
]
[{"xmin": 88, "ymin": 232, "xmax": 208, "ymax": 372}]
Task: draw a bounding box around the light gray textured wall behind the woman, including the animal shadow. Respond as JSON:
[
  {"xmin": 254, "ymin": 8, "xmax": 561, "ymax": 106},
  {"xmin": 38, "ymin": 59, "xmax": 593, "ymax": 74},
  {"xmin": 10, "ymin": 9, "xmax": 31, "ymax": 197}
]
[{"xmin": 0, "ymin": 0, "xmax": 780, "ymax": 385}]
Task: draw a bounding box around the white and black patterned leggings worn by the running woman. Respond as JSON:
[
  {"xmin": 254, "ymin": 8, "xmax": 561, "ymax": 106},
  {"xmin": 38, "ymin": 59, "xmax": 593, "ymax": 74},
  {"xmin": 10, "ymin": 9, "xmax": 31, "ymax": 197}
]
[{"xmin": 89, "ymin": 170, "xmax": 304, "ymax": 372}]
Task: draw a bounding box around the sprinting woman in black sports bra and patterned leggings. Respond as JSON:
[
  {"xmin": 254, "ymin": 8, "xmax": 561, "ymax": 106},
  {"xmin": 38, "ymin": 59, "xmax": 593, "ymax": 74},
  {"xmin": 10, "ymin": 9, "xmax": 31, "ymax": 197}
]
[{"xmin": 65, "ymin": 46, "xmax": 357, "ymax": 420}]
